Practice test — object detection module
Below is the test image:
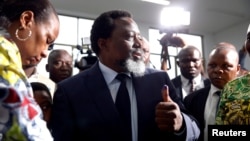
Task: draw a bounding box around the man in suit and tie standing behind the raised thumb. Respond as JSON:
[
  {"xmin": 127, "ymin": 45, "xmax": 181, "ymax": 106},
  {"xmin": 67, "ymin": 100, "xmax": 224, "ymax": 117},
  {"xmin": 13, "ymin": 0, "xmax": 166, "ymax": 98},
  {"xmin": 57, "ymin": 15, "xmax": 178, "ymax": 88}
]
[{"xmin": 171, "ymin": 45, "xmax": 210, "ymax": 100}]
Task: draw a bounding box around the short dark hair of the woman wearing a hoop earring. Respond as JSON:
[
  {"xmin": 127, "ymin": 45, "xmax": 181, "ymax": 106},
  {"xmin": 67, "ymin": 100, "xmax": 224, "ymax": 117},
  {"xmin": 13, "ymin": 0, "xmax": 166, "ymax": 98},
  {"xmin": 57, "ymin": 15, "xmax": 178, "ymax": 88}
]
[{"xmin": 0, "ymin": 0, "xmax": 57, "ymax": 28}]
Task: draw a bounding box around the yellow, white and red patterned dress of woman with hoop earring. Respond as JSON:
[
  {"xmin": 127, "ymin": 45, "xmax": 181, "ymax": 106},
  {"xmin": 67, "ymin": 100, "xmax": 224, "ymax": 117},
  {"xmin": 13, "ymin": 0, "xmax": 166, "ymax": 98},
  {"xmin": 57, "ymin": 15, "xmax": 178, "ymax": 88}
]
[{"xmin": 0, "ymin": 36, "xmax": 53, "ymax": 141}]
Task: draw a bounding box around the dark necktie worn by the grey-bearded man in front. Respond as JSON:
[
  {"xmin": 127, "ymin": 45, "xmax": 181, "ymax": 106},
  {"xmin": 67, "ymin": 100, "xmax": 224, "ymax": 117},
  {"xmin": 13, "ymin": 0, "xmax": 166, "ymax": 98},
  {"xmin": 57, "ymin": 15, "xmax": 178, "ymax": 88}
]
[{"xmin": 115, "ymin": 74, "xmax": 132, "ymax": 140}]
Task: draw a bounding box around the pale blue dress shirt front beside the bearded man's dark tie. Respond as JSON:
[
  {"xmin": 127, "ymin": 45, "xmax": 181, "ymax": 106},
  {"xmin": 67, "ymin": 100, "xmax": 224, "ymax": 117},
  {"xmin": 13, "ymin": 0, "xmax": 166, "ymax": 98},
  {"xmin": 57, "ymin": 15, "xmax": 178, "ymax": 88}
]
[{"xmin": 99, "ymin": 61, "xmax": 138, "ymax": 141}]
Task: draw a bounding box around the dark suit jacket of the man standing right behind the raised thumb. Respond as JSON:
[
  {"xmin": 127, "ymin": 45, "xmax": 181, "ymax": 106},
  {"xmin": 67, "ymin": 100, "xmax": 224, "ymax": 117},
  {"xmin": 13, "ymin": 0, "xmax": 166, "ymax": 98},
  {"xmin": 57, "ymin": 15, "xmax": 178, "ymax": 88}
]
[{"xmin": 171, "ymin": 75, "xmax": 211, "ymax": 100}]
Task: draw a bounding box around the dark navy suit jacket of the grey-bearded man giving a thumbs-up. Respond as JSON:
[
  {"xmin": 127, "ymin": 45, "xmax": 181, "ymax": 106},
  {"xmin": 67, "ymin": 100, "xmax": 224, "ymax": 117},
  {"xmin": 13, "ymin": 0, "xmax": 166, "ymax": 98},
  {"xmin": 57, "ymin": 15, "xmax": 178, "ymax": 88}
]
[{"xmin": 52, "ymin": 63, "xmax": 200, "ymax": 141}]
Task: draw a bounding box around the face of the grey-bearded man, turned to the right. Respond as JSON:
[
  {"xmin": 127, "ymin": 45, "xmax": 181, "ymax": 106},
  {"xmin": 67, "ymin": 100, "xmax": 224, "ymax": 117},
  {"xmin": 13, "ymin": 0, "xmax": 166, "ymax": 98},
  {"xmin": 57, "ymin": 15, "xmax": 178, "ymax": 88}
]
[{"xmin": 100, "ymin": 17, "xmax": 145, "ymax": 75}]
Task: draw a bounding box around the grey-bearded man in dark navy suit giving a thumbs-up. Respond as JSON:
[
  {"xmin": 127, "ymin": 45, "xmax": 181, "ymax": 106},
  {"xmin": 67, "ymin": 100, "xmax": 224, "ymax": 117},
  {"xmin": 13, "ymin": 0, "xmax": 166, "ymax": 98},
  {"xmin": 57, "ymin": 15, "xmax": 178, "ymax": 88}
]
[{"xmin": 52, "ymin": 10, "xmax": 200, "ymax": 141}]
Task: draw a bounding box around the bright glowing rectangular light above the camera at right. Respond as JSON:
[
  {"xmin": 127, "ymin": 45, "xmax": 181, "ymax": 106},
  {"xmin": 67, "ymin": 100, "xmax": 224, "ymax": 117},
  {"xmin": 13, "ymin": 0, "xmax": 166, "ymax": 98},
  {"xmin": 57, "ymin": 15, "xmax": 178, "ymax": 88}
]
[{"xmin": 160, "ymin": 7, "xmax": 190, "ymax": 27}]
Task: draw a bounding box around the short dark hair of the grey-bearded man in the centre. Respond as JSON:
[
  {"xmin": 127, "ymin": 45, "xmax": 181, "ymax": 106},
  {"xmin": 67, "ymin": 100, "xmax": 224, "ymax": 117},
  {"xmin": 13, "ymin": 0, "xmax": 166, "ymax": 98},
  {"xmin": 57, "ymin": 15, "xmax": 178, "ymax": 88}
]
[{"xmin": 90, "ymin": 10, "xmax": 132, "ymax": 56}]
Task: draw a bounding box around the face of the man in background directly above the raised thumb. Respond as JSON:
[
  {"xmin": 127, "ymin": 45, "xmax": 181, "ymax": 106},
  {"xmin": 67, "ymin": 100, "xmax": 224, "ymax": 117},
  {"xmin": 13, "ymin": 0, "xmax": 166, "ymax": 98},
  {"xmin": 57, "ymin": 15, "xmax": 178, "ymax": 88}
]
[{"xmin": 179, "ymin": 49, "xmax": 202, "ymax": 79}]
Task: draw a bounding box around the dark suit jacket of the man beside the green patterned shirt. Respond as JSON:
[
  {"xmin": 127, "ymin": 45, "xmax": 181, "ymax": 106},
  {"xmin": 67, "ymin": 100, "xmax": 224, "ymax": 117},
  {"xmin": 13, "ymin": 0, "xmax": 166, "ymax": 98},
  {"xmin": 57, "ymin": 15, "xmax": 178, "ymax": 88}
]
[{"xmin": 184, "ymin": 85, "xmax": 211, "ymax": 141}]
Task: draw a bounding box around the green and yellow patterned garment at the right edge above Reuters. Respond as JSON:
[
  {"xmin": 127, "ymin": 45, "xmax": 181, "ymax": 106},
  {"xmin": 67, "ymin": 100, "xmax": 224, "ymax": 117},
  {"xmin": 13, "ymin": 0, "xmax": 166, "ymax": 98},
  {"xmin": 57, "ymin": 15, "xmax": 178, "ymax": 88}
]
[{"xmin": 216, "ymin": 73, "xmax": 250, "ymax": 125}]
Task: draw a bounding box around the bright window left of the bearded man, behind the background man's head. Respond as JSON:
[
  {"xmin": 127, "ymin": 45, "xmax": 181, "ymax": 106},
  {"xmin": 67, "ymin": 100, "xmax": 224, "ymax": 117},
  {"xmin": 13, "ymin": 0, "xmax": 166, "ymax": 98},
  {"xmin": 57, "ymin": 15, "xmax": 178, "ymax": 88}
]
[{"xmin": 37, "ymin": 15, "xmax": 94, "ymax": 77}]
